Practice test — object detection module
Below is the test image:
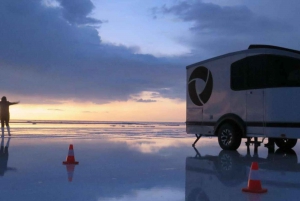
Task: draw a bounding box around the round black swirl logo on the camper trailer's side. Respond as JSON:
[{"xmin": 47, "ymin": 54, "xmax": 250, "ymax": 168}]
[{"xmin": 188, "ymin": 66, "xmax": 213, "ymax": 106}]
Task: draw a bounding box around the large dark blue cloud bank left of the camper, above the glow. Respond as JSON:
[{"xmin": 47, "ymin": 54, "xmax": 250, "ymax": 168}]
[{"xmin": 0, "ymin": 0, "xmax": 186, "ymax": 103}]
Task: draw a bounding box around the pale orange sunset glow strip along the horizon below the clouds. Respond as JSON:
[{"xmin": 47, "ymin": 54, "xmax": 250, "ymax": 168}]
[{"xmin": 10, "ymin": 98, "xmax": 185, "ymax": 122}]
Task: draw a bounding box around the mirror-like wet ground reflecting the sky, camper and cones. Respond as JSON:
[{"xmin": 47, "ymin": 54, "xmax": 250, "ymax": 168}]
[{"xmin": 0, "ymin": 121, "xmax": 300, "ymax": 201}]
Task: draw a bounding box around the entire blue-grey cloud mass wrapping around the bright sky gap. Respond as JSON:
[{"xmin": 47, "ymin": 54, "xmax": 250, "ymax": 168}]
[{"xmin": 8, "ymin": 0, "xmax": 300, "ymax": 107}]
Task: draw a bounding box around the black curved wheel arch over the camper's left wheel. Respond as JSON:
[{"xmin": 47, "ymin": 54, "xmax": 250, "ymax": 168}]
[{"xmin": 214, "ymin": 113, "xmax": 246, "ymax": 137}]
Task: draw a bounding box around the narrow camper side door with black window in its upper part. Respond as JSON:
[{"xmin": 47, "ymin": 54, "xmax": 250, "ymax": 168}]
[{"xmin": 246, "ymin": 55, "xmax": 265, "ymax": 134}]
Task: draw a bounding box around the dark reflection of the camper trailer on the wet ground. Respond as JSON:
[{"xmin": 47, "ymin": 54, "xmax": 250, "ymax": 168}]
[{"xmin": 185, "ymin": 146, "xmax": 300, "ymax": 201}]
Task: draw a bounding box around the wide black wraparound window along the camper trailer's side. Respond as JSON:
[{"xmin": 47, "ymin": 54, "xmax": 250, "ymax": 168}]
[{"xmin": 231, "ymin": 55, "xmax": 300, "ymax": 91}]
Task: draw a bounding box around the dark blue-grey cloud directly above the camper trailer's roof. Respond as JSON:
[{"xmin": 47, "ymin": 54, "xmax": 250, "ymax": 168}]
[{"xmin": 152, "ymin": 1, "xmax": 300, "ymax": 59}]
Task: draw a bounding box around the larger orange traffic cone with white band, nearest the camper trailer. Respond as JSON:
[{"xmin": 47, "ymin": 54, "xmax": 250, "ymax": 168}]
[{"xmin": 242, "ymin": 162, "xmax": 268, "ymax": 193}]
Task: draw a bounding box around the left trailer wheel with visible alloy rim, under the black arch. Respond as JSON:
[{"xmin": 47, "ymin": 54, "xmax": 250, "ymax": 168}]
[{"xmin": 218, "ymin": 123, "xmax": 242, "ymax": 150}]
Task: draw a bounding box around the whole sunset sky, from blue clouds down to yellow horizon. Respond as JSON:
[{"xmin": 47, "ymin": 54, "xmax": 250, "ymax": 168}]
[{"xmin": 0, "ymin": 0, "xmax": 300, "ymax": 122}]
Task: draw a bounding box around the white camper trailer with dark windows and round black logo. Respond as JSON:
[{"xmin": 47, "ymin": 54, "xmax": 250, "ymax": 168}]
[{"xmin": 186, "ymin": 45, "xmax": 300, "ymax": 150}]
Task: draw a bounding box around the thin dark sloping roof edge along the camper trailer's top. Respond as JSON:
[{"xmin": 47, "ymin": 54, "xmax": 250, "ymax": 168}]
[{"xmin": 186, "ymin": 44, "xmax": 300, "ymax": 69}]
